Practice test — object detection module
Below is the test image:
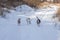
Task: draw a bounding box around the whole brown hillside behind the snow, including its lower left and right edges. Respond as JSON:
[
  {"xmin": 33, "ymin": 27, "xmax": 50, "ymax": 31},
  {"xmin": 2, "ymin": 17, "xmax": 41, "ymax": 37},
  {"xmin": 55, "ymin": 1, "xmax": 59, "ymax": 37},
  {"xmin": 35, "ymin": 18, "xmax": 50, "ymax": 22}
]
[{"xmin": 0, "ymin": 0, "xmax": 60, "ymax": 19}]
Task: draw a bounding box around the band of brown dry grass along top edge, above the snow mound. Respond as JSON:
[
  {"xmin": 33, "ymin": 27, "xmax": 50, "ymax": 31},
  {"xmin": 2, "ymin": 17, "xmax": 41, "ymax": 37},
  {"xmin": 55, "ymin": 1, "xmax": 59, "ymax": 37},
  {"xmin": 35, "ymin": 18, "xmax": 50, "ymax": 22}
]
[{"xmin": 0, "ymin": 0, "xmax": 60, "ymax": 8}]
